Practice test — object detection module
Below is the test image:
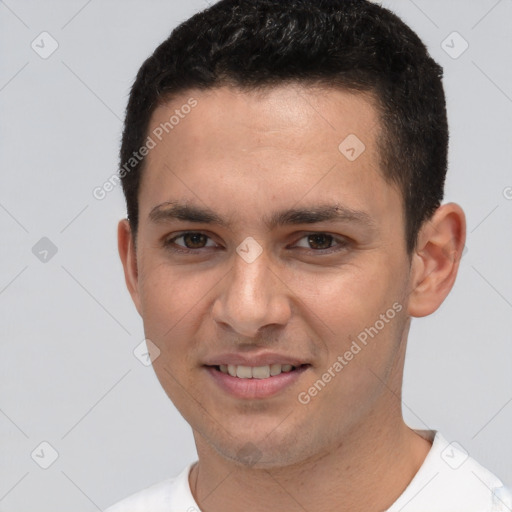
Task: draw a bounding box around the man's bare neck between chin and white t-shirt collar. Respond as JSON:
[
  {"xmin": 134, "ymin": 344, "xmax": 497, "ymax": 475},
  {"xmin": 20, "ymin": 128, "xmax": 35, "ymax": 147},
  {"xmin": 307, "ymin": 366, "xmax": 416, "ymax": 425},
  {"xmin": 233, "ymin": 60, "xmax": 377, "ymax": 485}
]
[{"xmin": 189, "ymin": 415, "xmax": 431, "ymax": 512}]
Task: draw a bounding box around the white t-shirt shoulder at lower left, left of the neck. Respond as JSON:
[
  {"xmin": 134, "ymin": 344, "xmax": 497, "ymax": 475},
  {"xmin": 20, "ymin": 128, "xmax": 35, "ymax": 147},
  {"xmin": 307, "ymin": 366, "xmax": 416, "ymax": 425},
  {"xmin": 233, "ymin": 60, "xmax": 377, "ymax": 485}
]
[{"xmin": 105, "ymin": 464, "xmax": 196, "ymax": 512}]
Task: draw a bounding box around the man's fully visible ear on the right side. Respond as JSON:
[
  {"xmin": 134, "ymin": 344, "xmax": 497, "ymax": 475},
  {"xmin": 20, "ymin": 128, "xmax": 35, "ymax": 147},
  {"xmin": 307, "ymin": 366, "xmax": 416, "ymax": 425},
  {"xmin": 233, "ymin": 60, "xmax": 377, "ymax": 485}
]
[{"xmin": 408, "ymin": 203, "xmax": 466, "ymax": 317}]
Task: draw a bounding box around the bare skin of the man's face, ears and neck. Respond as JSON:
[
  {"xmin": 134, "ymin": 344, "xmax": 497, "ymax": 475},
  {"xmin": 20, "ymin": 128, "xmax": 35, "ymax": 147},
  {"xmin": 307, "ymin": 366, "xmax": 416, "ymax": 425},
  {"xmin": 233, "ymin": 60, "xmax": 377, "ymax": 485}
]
[{"xmin": 118, "ymin": 85, "xmax": 465, "ymax": 512}]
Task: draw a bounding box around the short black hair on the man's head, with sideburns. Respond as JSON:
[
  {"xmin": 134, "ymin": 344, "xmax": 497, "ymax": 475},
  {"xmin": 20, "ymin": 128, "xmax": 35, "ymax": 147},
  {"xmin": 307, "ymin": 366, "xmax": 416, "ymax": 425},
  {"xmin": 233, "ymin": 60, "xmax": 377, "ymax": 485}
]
[{"xmin": 120, "ymin": 0, "xmax": 448, "ymax": 254}]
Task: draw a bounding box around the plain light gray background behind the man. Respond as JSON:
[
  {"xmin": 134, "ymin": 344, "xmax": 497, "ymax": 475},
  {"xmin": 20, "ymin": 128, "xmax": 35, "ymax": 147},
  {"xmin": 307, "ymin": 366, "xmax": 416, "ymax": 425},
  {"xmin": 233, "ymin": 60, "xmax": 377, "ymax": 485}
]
[{"xmin": 0, "ymin": 0, "xmax": 512, "ymax": 512}]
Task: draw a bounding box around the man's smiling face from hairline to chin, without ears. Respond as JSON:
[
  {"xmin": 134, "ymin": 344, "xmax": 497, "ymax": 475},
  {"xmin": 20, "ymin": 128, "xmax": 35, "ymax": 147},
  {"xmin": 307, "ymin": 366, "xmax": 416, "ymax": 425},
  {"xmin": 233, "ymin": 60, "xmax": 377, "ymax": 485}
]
[{"xmin": 121, "ymin": 85, "xmax": 416, "ymax": 466}]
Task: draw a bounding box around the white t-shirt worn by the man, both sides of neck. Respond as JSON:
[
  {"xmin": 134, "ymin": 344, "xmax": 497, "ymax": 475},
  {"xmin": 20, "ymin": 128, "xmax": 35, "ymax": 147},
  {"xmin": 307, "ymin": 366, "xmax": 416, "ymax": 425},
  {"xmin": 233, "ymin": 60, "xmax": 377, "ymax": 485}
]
[{"xmin": 105, "ymin": 430, "xmax": 512, "ymax": 512}]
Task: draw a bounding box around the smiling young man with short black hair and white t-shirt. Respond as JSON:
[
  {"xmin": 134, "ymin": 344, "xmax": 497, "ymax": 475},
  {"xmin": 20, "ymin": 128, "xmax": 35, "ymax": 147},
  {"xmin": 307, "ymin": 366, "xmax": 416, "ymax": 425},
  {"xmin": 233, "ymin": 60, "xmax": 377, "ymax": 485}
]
[{"xmin": 108, "ymin": 0, "xmax": 510, "ymax": 512}]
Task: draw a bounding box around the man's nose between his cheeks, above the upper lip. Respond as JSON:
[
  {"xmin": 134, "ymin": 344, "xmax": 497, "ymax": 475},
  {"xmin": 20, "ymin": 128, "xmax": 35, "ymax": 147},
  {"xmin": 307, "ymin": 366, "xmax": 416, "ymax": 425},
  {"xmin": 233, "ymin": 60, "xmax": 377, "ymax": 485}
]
[{"xmin": 212, "ymin": 245, "xmax": 291, "ymax": 338}]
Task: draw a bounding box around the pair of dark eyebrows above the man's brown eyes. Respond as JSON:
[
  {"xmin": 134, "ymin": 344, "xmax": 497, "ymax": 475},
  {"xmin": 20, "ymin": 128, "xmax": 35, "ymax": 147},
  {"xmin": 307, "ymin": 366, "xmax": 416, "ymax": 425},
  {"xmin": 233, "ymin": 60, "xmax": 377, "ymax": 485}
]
[{"xmin": 149, "ymin": 201, "xmax": 375, "ymax": 229}]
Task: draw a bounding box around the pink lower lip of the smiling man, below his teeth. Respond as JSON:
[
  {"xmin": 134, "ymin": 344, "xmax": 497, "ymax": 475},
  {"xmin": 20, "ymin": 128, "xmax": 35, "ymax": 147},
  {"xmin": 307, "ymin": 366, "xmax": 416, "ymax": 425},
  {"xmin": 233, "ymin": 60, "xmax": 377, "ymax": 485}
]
[{"xmin": 206, "ymin": 365, "xmax": 309, "ymax": 399}]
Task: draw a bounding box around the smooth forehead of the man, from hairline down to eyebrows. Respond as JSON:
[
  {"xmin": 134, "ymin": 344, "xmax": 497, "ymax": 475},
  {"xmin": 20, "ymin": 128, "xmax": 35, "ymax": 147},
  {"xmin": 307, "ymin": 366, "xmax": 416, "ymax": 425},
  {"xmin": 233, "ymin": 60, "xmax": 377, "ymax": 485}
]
[{"xmin": 139, "ymin": 85, "xmax": 396, "ymax": 226}]
